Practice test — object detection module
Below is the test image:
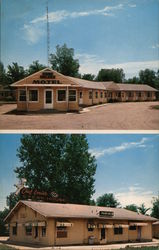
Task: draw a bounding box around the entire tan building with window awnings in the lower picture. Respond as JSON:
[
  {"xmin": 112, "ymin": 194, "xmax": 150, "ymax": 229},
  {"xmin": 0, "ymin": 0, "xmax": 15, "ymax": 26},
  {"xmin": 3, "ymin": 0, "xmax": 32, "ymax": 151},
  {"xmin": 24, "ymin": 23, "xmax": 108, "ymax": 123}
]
[{"xmin": 5, "ymin": 200, "xmax": 157, "ymax": 246}]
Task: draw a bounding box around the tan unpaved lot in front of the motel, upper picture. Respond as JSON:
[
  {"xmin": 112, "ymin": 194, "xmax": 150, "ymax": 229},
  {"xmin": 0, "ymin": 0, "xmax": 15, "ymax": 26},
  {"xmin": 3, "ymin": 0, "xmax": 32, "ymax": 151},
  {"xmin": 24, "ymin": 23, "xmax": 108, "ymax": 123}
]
[{"xmin": 0, "ymin": 102, "xmax": 159, "ymax": 130}]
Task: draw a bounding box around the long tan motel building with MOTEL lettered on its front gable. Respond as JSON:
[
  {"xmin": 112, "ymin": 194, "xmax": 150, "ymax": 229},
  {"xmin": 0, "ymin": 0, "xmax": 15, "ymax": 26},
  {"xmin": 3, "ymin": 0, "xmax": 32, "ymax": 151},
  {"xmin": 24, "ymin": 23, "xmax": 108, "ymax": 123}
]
[{"xmin": 12, "ymin": 68, "xmax": 158, "ymax": 111}]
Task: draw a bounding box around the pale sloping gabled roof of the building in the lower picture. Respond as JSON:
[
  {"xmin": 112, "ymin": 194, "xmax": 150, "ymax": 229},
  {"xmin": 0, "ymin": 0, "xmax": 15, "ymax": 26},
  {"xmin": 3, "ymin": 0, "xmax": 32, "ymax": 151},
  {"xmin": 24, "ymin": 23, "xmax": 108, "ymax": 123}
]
[{"xmin": 5, "ymin": 201, "xmax": 157, "ymax": 222}]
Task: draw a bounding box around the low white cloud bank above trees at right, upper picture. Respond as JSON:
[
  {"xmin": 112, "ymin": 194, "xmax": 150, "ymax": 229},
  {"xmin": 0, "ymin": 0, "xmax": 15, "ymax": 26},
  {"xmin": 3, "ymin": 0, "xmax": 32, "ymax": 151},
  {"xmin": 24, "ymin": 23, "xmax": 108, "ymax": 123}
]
[{"xmin": 76, "ymin": 53, "xmax": 159, "ymax": 78}]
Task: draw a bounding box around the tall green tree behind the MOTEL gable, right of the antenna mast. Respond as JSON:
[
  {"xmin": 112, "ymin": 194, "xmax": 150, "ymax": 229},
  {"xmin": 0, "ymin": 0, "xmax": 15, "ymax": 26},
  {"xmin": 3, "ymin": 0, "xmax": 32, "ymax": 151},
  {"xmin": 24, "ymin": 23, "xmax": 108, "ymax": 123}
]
[{"xmin": 50, "ymin": 44, "xmax": 80, "ymax": 77}]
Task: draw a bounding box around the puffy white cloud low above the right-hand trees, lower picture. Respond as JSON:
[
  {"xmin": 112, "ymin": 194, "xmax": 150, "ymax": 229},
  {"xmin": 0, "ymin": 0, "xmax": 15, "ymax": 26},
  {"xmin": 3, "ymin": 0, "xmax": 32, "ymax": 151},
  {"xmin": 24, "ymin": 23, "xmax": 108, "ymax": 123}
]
[{"xmin": 114, "ymin": 185, "xmax": 154, "ymax": 208}]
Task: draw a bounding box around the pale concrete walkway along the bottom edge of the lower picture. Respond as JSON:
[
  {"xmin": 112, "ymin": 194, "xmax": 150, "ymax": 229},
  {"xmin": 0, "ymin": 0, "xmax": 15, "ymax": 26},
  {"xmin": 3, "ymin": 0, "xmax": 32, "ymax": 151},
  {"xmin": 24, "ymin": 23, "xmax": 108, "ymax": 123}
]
[{"xmin": 0, "ymin": 237, "xmax": 159, "ymax": 250}]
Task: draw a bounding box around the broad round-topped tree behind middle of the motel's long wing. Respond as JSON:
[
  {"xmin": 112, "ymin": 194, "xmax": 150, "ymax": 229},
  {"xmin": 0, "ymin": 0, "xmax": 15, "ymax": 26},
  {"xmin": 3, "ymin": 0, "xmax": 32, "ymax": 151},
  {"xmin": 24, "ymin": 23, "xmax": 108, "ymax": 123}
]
[{"xmin": 96, "ymin": 69, "xmax": 125, "ymax": 83}]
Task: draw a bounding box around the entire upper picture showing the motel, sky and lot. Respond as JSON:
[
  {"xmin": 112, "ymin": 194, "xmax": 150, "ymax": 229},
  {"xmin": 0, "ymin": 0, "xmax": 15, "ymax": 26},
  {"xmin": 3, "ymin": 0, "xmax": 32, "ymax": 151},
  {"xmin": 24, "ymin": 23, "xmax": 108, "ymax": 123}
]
[{"xmin": 0, "ymin": 0, "xmax": 159, "ymax": 131}]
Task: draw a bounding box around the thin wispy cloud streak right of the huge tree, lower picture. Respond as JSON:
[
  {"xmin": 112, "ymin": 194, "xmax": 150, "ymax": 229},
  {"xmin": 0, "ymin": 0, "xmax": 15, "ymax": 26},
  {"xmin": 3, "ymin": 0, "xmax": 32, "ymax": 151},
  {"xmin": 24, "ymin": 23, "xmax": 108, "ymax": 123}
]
[{"xmin": 90, "ymin": 137, "xmax": 148, "ymax": 158}]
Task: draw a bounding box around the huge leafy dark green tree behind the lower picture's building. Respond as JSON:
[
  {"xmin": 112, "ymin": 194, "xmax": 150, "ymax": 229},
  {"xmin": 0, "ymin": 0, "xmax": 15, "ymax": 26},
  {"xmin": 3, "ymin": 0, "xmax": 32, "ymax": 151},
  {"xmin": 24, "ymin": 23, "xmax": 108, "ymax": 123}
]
[{"xmin": 11, "ymin": 134, "xmax": 96, "ymax": 204}]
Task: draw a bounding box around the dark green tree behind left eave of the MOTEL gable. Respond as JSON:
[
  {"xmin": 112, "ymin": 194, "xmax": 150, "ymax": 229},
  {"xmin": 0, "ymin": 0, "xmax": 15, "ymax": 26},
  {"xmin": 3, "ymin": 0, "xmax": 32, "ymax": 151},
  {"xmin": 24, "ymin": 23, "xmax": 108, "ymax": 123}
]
[{"xmin": 7, "ymin": 62, "xmax": 26, "ymax": 84}]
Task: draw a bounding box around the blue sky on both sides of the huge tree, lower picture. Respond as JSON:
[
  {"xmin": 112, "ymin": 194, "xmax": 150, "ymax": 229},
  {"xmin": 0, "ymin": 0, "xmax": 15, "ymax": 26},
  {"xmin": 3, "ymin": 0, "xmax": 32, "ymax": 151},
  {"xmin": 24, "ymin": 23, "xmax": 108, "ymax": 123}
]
[{"xmin": 0, "ymin": 134, "xmax": 159, "ymax": 209}]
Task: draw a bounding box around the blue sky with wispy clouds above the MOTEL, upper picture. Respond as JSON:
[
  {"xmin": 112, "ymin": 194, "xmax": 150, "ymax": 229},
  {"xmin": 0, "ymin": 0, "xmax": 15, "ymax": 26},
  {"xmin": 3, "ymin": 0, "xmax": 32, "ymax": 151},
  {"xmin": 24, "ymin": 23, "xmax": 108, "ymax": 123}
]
[{"xmin": 1, "ymin": 0, "xmax": 159, "ymax": 77}]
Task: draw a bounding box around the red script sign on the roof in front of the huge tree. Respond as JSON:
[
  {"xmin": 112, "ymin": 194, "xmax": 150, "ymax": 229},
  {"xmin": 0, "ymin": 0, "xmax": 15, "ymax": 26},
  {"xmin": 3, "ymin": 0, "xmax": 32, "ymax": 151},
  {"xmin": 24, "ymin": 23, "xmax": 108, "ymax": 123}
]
[{"xmin": 20, "ymin": 187, "xmax": 65, "ymax": 202}]
